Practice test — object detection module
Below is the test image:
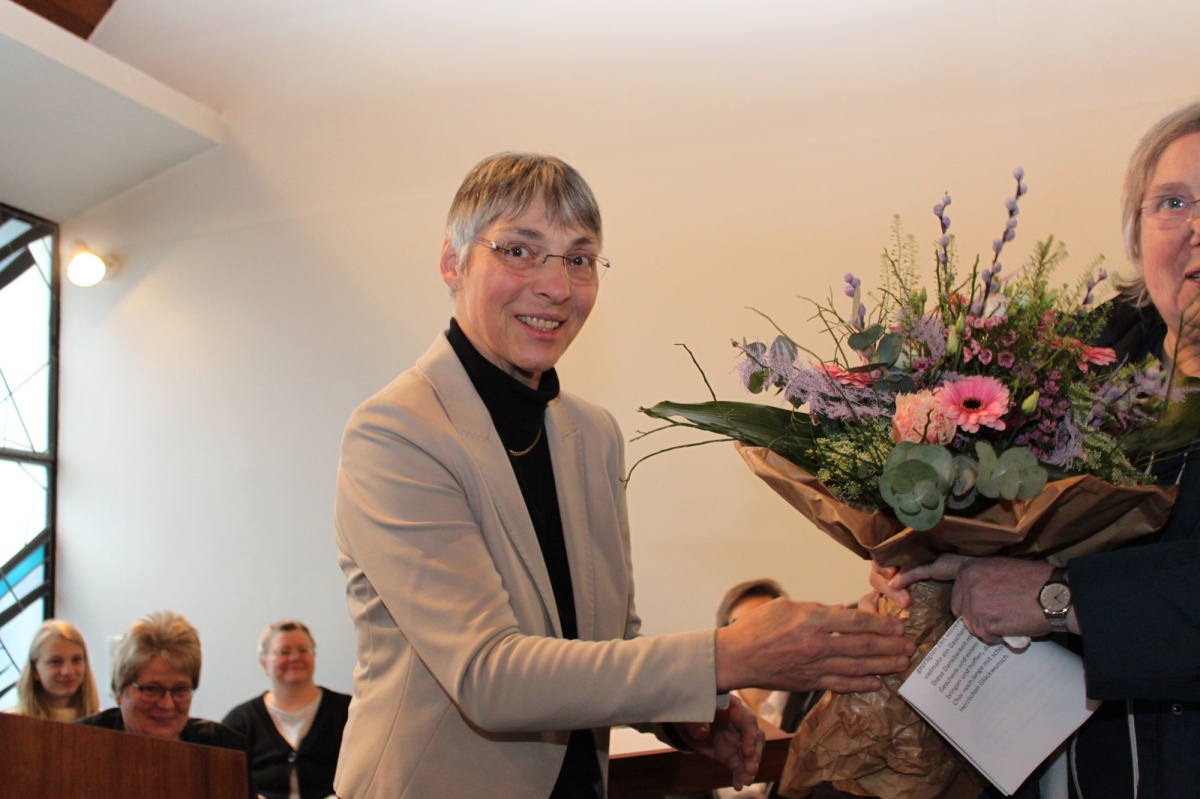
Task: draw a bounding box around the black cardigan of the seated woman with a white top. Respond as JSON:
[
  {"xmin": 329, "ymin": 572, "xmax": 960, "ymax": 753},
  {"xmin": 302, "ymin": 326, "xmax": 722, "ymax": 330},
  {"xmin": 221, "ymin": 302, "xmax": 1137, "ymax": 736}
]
[{"xmin": 222, "ymin": 689, "xmax": 350, "ymax": 799}]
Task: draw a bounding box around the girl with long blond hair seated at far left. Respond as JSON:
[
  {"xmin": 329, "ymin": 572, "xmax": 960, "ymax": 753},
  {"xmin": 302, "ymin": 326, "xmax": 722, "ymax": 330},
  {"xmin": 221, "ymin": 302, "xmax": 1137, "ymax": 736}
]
[{"xmin": 13, "ymin": 619, "xmax": 100, "ymax": 721}]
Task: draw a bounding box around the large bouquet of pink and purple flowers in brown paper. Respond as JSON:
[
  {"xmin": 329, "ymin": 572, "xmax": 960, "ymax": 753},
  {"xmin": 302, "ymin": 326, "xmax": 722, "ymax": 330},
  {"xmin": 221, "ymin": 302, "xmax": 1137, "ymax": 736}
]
[{"xmin": 635, "ymin": 169, "xmax": 1195, "ymax": 799}]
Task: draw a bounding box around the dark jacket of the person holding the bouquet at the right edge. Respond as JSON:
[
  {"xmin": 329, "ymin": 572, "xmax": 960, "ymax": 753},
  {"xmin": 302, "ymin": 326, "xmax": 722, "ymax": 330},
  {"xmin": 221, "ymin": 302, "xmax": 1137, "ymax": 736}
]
[{"xmin": 998, "ymin": 304, "xmax": 1200, "ymax": 799}]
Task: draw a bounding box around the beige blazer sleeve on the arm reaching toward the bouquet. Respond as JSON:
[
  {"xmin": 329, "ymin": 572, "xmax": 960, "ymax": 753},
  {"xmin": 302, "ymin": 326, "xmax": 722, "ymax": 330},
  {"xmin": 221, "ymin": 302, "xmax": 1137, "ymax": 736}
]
[{"xmin": 336, "ymin": 372, "xmax": 716, "ymax": 733}]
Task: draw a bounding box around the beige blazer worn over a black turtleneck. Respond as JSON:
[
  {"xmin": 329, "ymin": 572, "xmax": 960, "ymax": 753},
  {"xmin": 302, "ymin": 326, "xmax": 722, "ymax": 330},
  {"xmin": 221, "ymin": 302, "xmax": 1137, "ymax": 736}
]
[{"xmin": 335, "ymin": 335, "xmax": 716, "ymax": 799}]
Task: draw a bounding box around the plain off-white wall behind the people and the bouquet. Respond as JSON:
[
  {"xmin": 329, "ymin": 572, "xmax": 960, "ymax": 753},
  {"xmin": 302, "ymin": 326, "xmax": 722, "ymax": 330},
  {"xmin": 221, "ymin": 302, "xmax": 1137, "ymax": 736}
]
[{"xmin": 44, "ymin": 0, "xmax": 1194, "ymax": 717}]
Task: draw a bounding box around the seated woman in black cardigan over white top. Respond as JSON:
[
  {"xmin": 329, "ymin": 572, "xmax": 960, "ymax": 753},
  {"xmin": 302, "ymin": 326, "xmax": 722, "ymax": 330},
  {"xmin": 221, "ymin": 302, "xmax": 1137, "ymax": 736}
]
[{"xmin": 222, "ymin": 621, "xmax": 350, "ymax": 799}]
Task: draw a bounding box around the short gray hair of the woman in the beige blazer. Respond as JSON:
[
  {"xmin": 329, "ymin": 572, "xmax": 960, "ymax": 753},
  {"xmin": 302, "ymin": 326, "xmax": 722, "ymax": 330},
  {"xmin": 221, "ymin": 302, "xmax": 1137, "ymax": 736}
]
[{"xmin": 446, "ymin": 152, "xmax": 604, "ymax": 266}]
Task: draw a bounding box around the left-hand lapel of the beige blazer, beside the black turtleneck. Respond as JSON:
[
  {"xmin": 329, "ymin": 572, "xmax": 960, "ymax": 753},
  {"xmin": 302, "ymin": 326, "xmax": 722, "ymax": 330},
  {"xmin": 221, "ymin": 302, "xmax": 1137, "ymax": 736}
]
[{"xmin": 418, "ymin": 335, "xmax": 561, "ymax": 636}]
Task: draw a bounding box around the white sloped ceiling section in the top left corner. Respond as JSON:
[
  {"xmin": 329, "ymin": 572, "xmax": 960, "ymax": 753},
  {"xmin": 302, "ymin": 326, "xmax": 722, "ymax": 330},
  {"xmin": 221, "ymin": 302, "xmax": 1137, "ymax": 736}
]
[{"xmin": 0, "ymin": 0, "xmax": 221, "ymax": 222}]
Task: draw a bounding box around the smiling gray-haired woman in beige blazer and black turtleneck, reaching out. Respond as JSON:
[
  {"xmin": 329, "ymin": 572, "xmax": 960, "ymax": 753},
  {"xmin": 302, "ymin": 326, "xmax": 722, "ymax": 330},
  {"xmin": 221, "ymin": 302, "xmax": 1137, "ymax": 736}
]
[{"xmin": 335, "ymin": 152, "xmax": 913, "ymax": 799}]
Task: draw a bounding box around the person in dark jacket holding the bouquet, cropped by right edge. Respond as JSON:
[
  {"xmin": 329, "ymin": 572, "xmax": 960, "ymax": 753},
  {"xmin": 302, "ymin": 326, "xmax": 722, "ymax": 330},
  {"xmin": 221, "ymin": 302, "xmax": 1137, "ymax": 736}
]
[{"xmin": 871, "ymin": 97, "xmax": 1200, "ymax": 799}]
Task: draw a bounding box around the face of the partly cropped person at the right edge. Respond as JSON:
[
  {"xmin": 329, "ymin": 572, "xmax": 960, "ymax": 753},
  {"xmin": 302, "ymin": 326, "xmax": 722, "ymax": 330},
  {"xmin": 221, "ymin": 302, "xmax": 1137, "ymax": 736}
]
[{"xmin": 1141, "ymin": 133, "xmax": 1200, "ymax": 376}]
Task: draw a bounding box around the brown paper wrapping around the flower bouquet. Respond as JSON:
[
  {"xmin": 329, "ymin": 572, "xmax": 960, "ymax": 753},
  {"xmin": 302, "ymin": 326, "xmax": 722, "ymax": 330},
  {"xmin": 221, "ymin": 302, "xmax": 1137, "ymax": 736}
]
[{"xmin": 737, "ymin": 444, "xmax": 1177, "ymax": 799}]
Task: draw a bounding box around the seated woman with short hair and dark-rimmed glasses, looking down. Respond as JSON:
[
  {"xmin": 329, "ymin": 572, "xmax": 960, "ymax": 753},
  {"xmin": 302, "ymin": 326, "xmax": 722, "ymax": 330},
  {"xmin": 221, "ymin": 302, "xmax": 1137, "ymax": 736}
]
[{"xmin": 78, "ymin": 611, "xmax": 246, "ymax": 751}]
